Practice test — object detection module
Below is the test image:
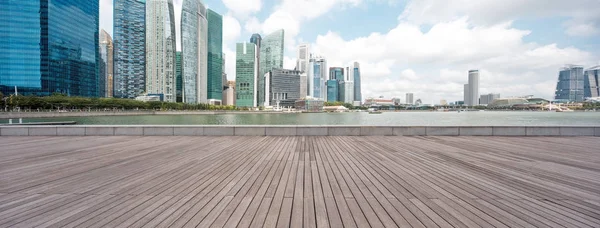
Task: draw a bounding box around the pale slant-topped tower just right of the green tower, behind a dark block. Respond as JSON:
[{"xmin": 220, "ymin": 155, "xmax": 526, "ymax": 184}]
[{"xmin": 257, "ymin": 29, "xmax": 285, "ymax": 106}]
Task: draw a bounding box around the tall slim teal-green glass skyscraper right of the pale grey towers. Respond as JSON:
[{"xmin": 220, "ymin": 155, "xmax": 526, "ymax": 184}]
[{"xmin": 206, "ymin": 9, "xmax": 223, "ymax": 104}]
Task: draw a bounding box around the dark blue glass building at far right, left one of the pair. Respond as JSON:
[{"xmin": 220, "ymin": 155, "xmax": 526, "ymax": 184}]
[{"xmin": 554, "ymin": 65, "xmax": 584, "ymax": 102}]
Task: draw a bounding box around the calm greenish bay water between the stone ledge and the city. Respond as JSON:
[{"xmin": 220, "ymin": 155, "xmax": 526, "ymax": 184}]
[{"xmin": 0, "ymin": 111, "xmax": 600, "ymax": 126}]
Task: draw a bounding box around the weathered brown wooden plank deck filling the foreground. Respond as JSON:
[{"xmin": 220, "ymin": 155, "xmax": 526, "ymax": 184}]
[{"xmin": 0, "ymin": 137, "xmax": 600, "ymax": 227}]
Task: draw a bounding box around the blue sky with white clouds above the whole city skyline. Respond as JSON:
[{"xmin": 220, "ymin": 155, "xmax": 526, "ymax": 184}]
[{"xmin": 100, "ymin": 0, "xmax": 600, "ymax": 104}]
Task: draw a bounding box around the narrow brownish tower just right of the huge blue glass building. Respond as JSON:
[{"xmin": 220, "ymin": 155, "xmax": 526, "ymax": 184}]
[{"xmin": 99, "ymin": 29, "xmax": 114, "ymax": 97}]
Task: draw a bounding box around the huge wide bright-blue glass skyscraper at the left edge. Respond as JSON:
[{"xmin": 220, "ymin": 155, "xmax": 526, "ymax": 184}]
[{"xmin": 0, "ymin": 0, "xmax": 100, "ymax": 97}]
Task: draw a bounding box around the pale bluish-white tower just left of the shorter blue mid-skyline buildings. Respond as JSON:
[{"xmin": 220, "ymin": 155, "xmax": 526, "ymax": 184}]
[{"xmin": 308, "ymin": 57, "xmax": 329, "ymax": 100}]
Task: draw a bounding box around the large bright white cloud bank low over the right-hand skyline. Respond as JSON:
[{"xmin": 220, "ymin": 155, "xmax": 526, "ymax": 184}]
[{"xmin": 312, "ymin": 17, "xmax": 597, "ymax": 103}]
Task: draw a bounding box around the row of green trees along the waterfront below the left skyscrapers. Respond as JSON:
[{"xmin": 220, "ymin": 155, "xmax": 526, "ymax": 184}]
[{"xmin": 0, "ymin": 94, "xmax": 237, "ymax": 111}]
